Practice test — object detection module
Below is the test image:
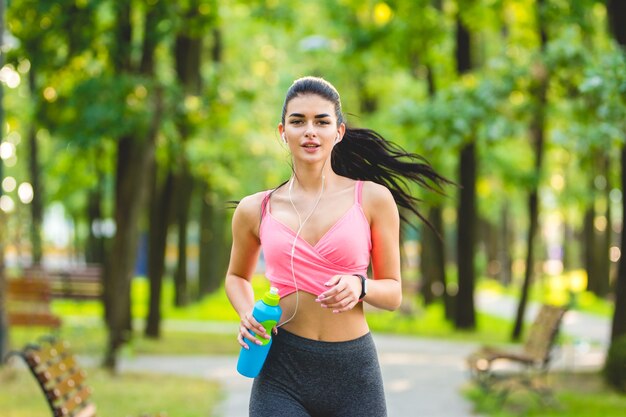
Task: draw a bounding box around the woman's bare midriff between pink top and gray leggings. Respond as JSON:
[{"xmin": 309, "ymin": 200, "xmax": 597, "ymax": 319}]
[{"xmin": 278, "ymin": 291, "xmax": 369, "ymax": 342}]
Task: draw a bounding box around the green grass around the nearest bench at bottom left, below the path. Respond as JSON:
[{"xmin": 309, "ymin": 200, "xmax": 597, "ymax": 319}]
[{"xmin": 0, "ymin": 367, "xmax": 222, "ymax": 417}]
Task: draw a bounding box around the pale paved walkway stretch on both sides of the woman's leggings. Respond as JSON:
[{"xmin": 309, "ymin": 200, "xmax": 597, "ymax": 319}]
[{"xmin": 121, "ymin": 335, "xmax": 475, "ymax": 417}]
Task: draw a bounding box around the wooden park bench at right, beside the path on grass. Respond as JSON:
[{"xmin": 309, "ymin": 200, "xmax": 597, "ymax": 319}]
[{"xmin": 467, "ymin": 304, "xmax": 566, "ymax": 401}]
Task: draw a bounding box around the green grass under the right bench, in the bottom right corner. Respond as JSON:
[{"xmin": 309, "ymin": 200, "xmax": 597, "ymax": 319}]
[{"xmin": 465, "ymin": 373, "xmax": 626, "ymax": 417}]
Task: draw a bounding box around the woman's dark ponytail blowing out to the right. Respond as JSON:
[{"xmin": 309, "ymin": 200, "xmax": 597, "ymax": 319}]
[{"xmin": 331, "ymin": 128, "xmax": 451, "ymax": 225}]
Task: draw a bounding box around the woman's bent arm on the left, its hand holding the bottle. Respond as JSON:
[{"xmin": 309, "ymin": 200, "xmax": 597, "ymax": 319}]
[{"xmin": 224, "ymin": 193, "xmax": 266, "ymax": 348}]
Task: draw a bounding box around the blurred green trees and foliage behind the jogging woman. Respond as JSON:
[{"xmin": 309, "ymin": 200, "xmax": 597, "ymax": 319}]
[{"xmin": 0, "ymin": 0, "xmax": 626, "ymax": 412}]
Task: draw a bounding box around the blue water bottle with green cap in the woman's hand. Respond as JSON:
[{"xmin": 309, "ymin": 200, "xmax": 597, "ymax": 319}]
[{"xmin": 237, "ymin": 287, "xmax": 283, "ymax": 378}]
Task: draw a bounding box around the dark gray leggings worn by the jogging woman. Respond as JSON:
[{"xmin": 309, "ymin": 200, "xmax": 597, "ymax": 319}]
[{"xmin": 249, "ymin": 329, "xmax": 387, "ymax": 417}]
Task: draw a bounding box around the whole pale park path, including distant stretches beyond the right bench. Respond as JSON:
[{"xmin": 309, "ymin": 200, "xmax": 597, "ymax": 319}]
[{"xmin": 121, "ymin": 293, "xmax": 609, "ymax": 417}]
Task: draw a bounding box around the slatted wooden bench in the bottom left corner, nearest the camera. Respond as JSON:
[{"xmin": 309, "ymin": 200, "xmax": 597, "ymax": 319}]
[{"xmin": 7, "ymin": 338, "xmax": 166, "ymax": 417}]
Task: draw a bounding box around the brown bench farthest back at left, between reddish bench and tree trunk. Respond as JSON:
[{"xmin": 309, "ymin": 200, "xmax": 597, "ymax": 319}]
[{"xmin": 23, "ymin": 265, "xmax": 102, "ymax": 301}]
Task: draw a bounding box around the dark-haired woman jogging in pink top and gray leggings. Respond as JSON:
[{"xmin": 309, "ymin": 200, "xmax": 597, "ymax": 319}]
[{"xmin": 225, "ymin": 77, "xmax": 447, "ymax": 417}]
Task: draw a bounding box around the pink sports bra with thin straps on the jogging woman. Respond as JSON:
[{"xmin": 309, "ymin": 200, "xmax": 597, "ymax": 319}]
[{"xmin": 259, "ymin": 181, "xmax": 372, "ymax": 297}]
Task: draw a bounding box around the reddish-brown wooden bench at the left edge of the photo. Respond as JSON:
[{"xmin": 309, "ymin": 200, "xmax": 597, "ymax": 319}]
[{"xmin": 6, "ymin": 278, "xmax": 61, "ymax": 329}]
